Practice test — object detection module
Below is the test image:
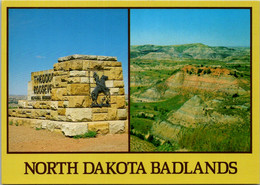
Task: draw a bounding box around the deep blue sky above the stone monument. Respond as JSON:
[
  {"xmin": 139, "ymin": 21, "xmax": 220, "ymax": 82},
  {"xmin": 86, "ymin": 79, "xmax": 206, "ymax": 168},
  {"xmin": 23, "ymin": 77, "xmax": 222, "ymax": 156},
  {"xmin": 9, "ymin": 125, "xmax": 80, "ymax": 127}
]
[{"xmin": 9, "ymin": 9, "xmax": 128, "ymax": 95}]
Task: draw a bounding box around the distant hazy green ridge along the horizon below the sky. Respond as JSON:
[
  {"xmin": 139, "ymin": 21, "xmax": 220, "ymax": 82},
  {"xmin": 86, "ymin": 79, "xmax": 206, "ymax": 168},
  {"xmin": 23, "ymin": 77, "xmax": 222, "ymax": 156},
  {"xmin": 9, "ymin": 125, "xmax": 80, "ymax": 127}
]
[{"xmin": 130, "ymin": 43, "xmax": 250, "ymax": 60}]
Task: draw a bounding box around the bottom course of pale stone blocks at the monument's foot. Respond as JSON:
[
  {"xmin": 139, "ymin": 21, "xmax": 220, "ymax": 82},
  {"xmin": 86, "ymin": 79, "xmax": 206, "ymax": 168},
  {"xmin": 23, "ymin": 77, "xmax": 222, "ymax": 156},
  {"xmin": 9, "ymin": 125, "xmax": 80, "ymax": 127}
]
[{"xmin": 9, "ymin": 117, "xmax": 128, "ymax": 136}]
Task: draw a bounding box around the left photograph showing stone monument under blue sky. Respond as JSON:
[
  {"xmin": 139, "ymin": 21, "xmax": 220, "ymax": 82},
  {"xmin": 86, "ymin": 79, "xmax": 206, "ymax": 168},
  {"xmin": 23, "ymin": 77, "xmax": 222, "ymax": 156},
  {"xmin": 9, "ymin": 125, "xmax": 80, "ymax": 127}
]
[{"xmin": 7, "ymin": 8, "xmax": 129, "ymax": 153}]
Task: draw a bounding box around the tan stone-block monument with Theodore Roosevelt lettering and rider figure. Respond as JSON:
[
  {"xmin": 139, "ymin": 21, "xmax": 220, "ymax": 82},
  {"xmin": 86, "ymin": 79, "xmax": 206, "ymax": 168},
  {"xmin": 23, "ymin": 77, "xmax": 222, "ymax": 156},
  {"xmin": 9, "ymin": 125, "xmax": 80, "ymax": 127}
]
[{"xmin": 9, "ymin": 55, "xmax": 128, "ymax": 136}]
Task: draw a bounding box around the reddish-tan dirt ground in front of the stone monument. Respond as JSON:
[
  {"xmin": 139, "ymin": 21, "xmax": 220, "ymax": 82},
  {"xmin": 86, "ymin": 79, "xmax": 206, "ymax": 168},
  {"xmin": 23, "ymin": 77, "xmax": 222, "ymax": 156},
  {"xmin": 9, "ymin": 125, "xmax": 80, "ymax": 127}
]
[{"xmin": 9, "ymin": 125, "xmax": 128, "ymax": 152}]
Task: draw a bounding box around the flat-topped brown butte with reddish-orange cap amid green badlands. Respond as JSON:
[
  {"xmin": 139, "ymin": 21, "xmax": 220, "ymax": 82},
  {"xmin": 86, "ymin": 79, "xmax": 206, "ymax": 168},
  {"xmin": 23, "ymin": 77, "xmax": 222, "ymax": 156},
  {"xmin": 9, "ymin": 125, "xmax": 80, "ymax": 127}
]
[{"xmin": 166, "ymin": 65, "xmax": 245, "ymax": 94}]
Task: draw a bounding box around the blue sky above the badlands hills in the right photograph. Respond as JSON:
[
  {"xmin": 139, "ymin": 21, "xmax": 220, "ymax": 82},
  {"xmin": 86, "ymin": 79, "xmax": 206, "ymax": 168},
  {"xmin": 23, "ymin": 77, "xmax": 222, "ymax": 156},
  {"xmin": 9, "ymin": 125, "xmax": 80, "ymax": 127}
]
[{"xmin": 130, "ymin": 9, "xmax": 250, "ymax": 46}]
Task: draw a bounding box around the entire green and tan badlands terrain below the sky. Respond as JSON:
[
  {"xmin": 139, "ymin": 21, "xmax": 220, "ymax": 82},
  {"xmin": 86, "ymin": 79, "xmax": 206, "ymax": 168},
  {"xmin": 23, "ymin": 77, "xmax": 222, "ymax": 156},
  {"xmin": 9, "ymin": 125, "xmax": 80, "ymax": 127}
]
[{"xmin": 130, "ymin": 43, "xmax": 251, "ymax": 152}]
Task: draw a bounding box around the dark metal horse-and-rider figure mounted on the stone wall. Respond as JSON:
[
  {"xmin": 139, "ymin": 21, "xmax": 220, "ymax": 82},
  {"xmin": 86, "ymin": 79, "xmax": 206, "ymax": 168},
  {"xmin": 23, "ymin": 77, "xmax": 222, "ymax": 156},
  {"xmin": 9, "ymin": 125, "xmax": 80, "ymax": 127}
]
[{"xmin": 91, "ymin": 72, "xmax": 110, "ymax": 107}]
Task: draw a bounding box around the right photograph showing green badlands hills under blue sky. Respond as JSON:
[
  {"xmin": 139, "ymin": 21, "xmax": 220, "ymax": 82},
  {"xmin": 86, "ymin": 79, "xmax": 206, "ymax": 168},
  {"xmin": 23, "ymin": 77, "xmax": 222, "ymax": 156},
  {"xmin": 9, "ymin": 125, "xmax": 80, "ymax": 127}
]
[{"xmin": 129, "ymin": 8, "xmax": 252, "ymax": 153}]
